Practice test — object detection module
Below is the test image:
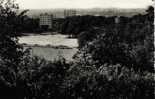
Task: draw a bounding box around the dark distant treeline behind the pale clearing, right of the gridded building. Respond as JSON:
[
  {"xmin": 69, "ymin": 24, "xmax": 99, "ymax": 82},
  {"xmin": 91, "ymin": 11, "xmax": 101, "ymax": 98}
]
[{"xmin": 61, "ymin": 10, "xmax": 152, "ymax": 37}]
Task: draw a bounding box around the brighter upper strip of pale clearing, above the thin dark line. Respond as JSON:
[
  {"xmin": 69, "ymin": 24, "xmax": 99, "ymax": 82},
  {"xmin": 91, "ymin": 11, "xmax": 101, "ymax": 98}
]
[{"xmin": 19, "ymin": 34, "xmax": 78, "ymax": 47}]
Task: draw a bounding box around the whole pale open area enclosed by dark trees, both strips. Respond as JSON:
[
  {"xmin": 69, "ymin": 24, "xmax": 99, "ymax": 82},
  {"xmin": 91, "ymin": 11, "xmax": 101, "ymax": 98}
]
[{"xmin": 19, "ymin": 34, "xmax": 78, "ymax": 60}]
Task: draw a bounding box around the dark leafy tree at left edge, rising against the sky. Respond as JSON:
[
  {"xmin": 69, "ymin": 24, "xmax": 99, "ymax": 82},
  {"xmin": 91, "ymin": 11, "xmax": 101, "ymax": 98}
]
[{"xmin": 0, "ymin": 0, "xmax": 22, "ymax": 69}]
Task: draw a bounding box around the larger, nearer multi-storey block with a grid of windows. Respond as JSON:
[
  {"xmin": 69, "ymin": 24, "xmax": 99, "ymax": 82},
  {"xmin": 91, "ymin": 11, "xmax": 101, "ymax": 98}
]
[{"xmin": 39, "ymin": 13, "xmax": 53, "ymax": 29}]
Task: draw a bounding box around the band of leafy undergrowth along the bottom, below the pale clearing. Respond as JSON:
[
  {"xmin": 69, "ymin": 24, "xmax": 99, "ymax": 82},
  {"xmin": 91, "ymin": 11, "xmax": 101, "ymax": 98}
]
[{"xmin": 0, "ymin": 57, "xmax": 154, "ymax": 99}]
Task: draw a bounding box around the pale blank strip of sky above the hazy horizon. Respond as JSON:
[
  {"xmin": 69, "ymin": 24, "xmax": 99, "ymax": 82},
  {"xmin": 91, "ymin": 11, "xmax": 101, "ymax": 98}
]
[{"xmin": 16, "ymin": 0, "xmax": 153, "ymax": 9}]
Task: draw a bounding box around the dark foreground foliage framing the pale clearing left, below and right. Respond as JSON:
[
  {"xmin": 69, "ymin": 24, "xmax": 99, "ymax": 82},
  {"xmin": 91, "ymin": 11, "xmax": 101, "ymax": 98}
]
[{"xmin": 0, "ymin": 0, "xmax": 155, "ymax": 99}]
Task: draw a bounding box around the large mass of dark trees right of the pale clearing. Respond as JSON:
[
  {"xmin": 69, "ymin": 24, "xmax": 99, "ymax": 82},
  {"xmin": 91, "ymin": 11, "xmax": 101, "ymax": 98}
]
[{"xmin": 75, "ymin": 7, "xmax": 154, "ymax": 71}]
